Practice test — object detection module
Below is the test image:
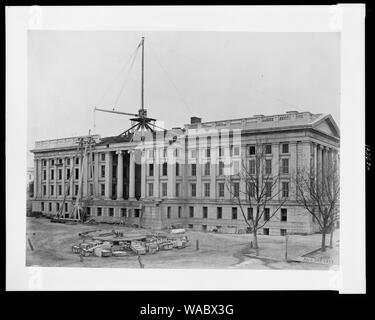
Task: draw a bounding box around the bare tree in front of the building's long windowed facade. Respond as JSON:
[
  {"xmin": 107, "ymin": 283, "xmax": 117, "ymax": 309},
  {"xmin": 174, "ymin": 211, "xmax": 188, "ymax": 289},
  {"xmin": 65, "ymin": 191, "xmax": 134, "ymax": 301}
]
[{"xmin": 226, "ymin": 141, "xmax": 289, "ymax": 255}]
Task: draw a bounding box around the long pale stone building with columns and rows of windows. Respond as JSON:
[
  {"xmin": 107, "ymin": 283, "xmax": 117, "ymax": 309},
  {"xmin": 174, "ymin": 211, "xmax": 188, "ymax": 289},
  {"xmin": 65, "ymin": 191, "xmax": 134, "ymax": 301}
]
[{"xmin": 32, "ymin": 111, "xmax": 340, "ymax": 235}]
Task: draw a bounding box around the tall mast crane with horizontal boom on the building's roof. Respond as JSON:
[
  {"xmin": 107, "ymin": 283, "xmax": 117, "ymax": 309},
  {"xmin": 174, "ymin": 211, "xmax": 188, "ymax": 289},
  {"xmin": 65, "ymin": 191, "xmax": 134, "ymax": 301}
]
[{"xmin": 94, "ymin": 37, "xmax": 166, "ymax": 141}]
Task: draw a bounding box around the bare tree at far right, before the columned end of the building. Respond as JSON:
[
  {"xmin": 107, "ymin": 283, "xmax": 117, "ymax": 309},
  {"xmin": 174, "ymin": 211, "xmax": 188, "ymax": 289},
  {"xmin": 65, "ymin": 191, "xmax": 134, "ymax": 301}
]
[{"xmin": 296, "ymin": 164, "xmax": 340, "ymax": 251}]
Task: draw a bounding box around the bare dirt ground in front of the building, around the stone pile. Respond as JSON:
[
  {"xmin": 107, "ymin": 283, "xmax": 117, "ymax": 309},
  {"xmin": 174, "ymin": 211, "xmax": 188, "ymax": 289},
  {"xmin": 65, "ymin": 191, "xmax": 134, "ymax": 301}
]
[{"xmin": 26, "ymin": 217, "xmax": 337, "ymax": 270}]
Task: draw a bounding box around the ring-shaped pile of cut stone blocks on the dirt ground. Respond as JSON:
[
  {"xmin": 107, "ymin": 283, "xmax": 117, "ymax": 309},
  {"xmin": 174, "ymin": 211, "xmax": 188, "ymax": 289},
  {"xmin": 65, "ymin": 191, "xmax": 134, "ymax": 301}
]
[{"xmin": 72, "ymin": 229, "xmax": 190, "ymax": 257}]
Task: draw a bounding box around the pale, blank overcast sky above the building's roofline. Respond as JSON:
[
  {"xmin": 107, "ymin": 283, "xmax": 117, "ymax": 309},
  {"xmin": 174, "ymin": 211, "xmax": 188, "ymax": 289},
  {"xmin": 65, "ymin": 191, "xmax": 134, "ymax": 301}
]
[{"xmin": 27, "ymin": 31, "xmax": 340, "ymax": 166}]
